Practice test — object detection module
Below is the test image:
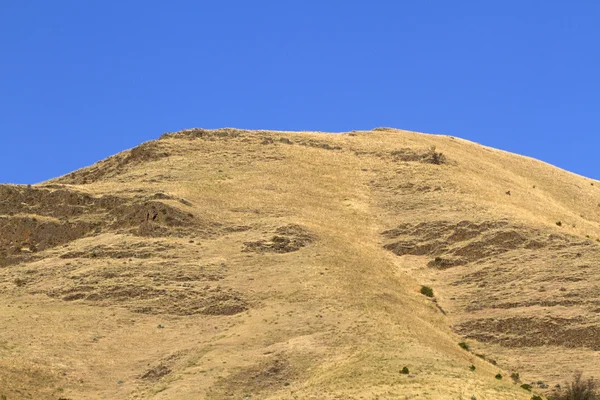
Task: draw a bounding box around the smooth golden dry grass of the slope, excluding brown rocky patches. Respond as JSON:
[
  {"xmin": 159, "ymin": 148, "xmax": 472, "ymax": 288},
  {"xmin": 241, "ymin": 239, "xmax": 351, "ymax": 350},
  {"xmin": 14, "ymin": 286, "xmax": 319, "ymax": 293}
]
[{"xmin": 0, "ymin": 130, "xmax": 600, "ymax": 399}]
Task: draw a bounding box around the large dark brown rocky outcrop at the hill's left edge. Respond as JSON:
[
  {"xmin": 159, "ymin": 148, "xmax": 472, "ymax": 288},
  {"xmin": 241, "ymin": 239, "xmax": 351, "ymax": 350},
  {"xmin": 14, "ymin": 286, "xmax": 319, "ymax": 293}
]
[{"xmin": 0, "ymin": 185, "xmax": 206, "ymax": 265}]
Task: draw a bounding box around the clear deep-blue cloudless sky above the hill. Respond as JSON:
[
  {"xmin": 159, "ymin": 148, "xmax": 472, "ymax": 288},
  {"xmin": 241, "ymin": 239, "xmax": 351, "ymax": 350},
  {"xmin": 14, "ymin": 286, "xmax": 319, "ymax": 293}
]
[{"xmin": 0, "ymin": 0, "xmax": 600, "ymax": 183}]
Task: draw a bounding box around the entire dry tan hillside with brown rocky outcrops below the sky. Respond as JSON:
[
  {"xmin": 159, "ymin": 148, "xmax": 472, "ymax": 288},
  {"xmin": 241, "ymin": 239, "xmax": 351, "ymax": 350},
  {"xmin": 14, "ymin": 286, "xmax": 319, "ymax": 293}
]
[{"xmin": 0, "ymin": 128, "xmax": 600, "ymax": 400}]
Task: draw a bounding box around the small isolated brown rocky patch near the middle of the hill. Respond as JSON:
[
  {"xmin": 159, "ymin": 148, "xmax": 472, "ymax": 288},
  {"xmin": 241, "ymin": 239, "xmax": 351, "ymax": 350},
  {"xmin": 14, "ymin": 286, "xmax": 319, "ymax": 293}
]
[{"xmin": 243, "ymin": 224, "xmax": 315, "ymax": 253}]
